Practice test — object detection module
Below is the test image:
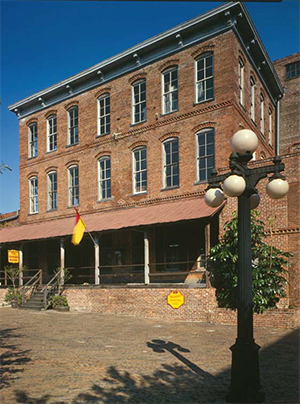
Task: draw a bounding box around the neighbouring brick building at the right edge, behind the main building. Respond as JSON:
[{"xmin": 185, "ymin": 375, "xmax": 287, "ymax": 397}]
[{"xmin": 274, "ymin": 52, "xmax": 300, "ymax": 154}]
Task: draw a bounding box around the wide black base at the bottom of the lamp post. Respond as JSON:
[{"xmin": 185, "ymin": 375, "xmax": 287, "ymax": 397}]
[{"xmin": 225, "ymin": 339, "xmax": 265, "ymax": 403}]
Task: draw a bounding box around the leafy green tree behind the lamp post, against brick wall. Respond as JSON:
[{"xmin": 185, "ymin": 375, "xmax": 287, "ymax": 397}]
[{"xmin": 208, "ymin": 211, "xmax": 292, "ymax": 313}]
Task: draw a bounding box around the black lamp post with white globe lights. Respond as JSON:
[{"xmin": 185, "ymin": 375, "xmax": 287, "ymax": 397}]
[{"xmin": 205, "ymin": 129, "xmax": 289, "ymax": 403}]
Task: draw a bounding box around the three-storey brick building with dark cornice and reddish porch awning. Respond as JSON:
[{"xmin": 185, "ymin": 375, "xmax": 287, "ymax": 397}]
[{"xmin": 0, "ymin": 2, "xmax": 298, "ymax": 326}]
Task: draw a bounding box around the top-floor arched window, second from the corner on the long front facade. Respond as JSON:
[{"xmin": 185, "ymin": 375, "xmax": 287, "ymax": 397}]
[{"xmin": 162, "ymin": 66, "xmax": 178, "ymax": 114}]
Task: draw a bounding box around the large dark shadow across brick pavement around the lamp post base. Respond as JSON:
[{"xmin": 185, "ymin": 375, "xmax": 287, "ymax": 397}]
[{"xmin": 9, "ymin": 330, "xmax": 299, "ymax": 404}]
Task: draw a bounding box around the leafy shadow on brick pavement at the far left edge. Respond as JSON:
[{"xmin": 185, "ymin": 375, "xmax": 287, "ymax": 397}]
[{"xmin": 0, "ymin": 328, "xmax": 31, "ymax": 389}]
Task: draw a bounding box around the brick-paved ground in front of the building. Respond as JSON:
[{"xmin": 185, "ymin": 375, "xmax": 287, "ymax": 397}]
[{"xmin": 0, "ymin": 308, "xmax": 299, "ymax": 404}]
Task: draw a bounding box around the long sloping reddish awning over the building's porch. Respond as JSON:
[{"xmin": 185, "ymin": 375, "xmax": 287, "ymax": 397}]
[{"xmin": 0, "ymin": 197, "xmax": 220, "ymax": 243}]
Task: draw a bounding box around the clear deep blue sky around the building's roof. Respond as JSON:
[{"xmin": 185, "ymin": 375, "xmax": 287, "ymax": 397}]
[{"xmin": 0, "ymin": 0, "xmax": 300, "ymax": 213}]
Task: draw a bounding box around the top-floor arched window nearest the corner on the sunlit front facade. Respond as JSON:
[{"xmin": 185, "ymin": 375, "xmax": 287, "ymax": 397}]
[{"xmin": 195, "ymin": 52, "xmax": 214, "ymax": 103}]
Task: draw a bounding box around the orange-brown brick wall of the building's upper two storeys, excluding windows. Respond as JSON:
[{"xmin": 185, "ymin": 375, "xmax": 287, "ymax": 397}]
[{"xmin": 20, "ymin": 32, "xmax": 275, "ymax": 227}]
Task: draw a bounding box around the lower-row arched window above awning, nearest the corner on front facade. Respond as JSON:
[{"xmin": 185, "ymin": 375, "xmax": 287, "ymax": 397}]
[{"xmin": 196, "ymin": 128, "xmax": 215, "ymax": 181}]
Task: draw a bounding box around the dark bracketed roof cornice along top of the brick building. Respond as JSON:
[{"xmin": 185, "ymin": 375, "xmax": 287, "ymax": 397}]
[{"xmin": 8, "ymin": 1, "xmax": 283, "ymax": 118}]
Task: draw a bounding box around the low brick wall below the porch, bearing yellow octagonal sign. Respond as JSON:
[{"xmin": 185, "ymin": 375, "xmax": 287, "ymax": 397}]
[{"xmin": 64, "ymin": 287, "xmax": 300, "ymax": 328}]
